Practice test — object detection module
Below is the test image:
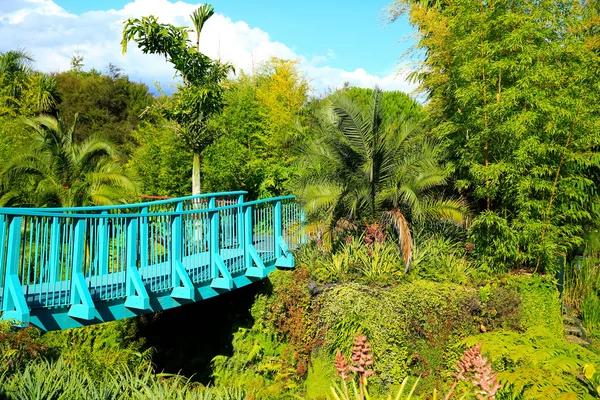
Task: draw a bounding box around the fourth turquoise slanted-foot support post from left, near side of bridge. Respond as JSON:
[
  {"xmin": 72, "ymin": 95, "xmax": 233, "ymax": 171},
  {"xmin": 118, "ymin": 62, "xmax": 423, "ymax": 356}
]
[{"xmin": 170, "ymin": 202, "xmax": 195, "ymax": 300}]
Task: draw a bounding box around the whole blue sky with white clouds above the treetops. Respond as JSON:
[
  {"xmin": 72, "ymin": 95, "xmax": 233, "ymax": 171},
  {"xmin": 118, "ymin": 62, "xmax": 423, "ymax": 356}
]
[{"xmin": 0, "ymin": 0, "xmax": 411, "ymax": 92}]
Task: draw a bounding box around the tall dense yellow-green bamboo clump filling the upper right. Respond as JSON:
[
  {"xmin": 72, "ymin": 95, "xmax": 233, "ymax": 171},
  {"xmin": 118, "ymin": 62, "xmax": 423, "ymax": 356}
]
[{"xmin": 391, "ymin": 0, "xmax": 600, "ymax": 273}]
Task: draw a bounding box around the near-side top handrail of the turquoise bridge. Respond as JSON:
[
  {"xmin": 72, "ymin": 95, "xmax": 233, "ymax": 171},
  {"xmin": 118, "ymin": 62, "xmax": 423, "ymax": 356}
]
[{"xmin": 0, "ymin": 196, "xmax": 296, "ymax": 219}]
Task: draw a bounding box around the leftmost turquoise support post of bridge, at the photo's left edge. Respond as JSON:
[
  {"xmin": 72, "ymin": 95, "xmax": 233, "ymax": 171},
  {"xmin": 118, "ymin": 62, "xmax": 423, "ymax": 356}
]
[{"xmin": 0, "ymin": 215, "xmax": 30, "ymax": 324}]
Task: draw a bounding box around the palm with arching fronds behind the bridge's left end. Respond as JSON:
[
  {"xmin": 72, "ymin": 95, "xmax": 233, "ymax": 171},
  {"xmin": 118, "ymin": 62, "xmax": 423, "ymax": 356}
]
[{"xmin": 0, "ymin": 112, "xmax": 137, "ymax": 207}]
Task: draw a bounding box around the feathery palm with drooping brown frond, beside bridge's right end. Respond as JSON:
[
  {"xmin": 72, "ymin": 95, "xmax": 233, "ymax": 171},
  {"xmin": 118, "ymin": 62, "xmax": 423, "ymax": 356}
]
[{"xmin": 300, "ymin": 89, "xmax": 466, "ymax": 269}]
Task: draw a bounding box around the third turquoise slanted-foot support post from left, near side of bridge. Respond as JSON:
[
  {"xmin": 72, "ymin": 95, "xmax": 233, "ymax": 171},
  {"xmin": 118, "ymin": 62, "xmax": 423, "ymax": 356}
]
[{"xmin": 125, "ymin": 218, "xmax": 151, "ymax": 310}]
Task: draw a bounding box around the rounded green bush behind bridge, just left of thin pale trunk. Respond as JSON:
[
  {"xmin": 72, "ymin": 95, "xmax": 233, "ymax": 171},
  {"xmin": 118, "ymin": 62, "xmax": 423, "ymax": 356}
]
[{"xmin": 127, "ymin": 120, "xmax": 192, "ymax": 197}]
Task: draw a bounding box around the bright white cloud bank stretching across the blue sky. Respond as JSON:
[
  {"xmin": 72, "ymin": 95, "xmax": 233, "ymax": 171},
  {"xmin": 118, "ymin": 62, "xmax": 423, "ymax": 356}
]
[{"xmin": 0, "ymin": 0, "xmax": 412, "ymax": 93}]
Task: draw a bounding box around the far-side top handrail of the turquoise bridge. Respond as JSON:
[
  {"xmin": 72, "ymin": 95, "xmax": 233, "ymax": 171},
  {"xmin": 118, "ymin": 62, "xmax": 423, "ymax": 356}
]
[{"xmin": 0, "ymin": 190, "xmax": 248, "ymax": 218}]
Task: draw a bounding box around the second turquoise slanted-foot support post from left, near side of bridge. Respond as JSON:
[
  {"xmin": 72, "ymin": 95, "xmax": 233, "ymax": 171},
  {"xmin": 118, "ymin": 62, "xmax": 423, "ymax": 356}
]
[{"xmin": 68, "ymin": 219, "xmax": 96, "ymax": 321}]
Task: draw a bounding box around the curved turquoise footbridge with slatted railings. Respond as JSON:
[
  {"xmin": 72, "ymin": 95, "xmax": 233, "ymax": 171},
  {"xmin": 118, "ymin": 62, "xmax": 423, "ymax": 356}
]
[{"xmin": 0, "ymin": 192, "xmax": 304, "ymax": 330}]
